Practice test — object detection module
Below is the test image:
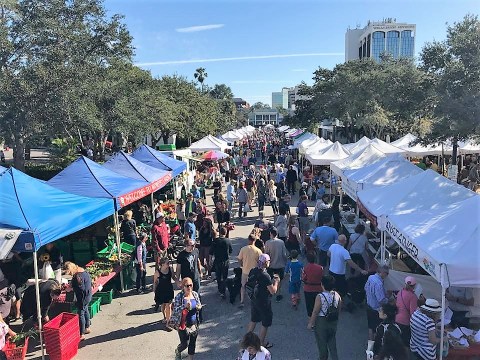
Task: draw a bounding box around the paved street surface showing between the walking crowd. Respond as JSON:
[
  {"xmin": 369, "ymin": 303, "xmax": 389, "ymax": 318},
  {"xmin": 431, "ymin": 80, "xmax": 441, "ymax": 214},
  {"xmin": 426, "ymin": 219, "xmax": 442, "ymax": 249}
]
[{"xmin": 28, "ymin": 188, "xmax": 367, "ymax": 360}]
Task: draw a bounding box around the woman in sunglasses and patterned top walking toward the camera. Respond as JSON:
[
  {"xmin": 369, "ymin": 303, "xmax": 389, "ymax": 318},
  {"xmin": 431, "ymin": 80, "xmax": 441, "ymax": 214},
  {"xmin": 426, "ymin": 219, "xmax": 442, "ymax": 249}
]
[{"xmin": 171, "ymin": 277, "xmax": 202, "ymax": 360}]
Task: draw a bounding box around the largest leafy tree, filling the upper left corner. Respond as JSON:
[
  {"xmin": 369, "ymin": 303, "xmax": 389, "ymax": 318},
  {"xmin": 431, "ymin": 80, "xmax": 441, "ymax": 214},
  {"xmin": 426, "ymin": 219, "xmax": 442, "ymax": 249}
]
[{"xmin": 0, "ymin": 0, "xmax": 132, "ymax": 170}]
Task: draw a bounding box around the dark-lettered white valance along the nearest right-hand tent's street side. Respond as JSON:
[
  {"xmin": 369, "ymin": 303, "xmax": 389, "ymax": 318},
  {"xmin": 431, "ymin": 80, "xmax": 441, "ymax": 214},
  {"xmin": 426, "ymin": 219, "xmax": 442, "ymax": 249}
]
[{"xmin": 386, "ymin": 218, "xmax": 440, "ymax": 280}]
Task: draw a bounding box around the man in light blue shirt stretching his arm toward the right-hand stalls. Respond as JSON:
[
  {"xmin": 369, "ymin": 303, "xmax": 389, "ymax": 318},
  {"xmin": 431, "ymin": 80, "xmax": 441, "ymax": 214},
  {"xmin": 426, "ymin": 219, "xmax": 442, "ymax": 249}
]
[{"xmin": 327, "ymin": 234, "xmax": 368, "ymax": 298}]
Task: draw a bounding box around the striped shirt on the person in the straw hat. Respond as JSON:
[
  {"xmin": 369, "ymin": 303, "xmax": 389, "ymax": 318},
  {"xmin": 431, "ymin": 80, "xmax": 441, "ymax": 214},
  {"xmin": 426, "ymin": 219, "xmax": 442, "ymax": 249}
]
[{"xmin": 410, "ymin": 309, "xmax": 436, "ymax": 360}]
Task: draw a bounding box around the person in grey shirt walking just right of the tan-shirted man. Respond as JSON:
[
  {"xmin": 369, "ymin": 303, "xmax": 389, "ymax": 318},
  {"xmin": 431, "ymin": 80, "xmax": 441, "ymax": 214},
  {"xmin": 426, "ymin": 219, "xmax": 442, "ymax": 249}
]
[{"xmin": 265, "ymin": 227, "xmax": 288, "ymax": 302}]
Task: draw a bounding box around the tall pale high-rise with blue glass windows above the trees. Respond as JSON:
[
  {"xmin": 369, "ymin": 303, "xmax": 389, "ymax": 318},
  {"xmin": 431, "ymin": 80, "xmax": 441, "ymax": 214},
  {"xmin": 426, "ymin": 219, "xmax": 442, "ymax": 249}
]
[{"xmin": 345, "ymin": 18, "xmax": 416, "ymax": 62}]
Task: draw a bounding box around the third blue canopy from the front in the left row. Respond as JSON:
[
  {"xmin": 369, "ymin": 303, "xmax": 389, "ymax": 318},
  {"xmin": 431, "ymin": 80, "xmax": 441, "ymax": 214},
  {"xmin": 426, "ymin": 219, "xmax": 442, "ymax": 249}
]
[{"xmin": 103, "ymin": 151, "xmax": 172, "ymax": 219}]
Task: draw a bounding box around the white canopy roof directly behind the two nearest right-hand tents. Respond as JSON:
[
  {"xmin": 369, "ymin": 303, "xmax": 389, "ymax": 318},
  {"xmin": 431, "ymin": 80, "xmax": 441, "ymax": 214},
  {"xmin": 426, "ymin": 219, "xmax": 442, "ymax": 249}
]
[{"xmin": 342, "ymin": 154, "xmax": 423, "ymax": 201}]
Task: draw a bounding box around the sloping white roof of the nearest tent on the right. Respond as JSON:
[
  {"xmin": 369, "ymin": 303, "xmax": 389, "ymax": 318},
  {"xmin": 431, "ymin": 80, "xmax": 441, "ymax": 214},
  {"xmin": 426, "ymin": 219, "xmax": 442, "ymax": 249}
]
[{"xmin": 387, "ymin": 194, "xmax": 480, "ymax": 287}]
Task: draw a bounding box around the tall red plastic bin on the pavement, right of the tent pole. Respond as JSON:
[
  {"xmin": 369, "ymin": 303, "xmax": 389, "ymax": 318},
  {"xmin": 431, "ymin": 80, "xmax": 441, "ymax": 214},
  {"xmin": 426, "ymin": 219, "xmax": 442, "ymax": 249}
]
[{"xmin": 43, "ymin": 313, "xmax": 80, "ymax": 360}]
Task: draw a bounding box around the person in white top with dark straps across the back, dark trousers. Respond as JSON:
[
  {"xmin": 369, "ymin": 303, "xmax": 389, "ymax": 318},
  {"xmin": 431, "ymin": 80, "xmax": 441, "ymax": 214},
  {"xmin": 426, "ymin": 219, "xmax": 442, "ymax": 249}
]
[{"xmin": 307, "ymin": 275, "xmax": 342, "ymax": 360}]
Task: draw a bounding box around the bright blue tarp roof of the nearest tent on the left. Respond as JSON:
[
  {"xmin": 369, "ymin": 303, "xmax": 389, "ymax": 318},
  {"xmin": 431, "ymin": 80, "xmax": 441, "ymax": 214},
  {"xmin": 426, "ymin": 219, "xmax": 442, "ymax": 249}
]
[{"xmin": 0, "ymin": 168, "xmax": 114, "ymax": 253}]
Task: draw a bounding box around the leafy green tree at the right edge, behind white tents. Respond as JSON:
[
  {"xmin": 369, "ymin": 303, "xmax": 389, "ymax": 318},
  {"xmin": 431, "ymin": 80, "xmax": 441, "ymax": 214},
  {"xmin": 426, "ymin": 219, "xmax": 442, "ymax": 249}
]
[{"xmin": 421, "ymin": 15, "xmax": 480, "ymax": 164}]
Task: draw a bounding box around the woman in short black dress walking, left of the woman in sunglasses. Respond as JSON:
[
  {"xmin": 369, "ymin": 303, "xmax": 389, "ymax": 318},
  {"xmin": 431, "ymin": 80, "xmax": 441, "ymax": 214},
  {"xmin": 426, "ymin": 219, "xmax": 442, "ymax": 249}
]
[{"xmin": 155, "ymin": 258, "xmax": 173, "ymax": 328}]
